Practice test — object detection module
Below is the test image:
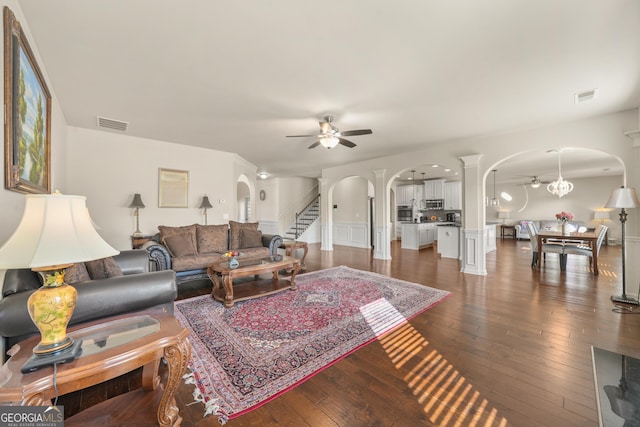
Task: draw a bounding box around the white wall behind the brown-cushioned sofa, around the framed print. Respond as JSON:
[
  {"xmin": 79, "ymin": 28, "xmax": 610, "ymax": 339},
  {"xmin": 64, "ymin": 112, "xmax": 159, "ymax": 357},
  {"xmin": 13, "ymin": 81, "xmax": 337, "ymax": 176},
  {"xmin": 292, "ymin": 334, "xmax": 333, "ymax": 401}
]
[{"xmin": 68, "ymin": 127, "xmax": 248, "ymax": 250}]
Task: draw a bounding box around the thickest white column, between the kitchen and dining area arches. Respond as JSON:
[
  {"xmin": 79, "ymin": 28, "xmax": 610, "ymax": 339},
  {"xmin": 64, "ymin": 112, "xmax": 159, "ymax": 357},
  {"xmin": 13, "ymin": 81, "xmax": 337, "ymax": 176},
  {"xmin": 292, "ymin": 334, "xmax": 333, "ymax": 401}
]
[{"xmin": 460, "ymin": 154, "xmax": 487, "ymax": 275}]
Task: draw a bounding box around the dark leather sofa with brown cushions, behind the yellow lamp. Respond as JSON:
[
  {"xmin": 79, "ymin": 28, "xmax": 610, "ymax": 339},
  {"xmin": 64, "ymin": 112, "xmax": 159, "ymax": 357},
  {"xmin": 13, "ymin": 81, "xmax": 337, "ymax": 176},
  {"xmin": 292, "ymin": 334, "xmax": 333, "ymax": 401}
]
[{"xmin": 0, "ymin": 250, "xmax": 178, "ymax": 361}]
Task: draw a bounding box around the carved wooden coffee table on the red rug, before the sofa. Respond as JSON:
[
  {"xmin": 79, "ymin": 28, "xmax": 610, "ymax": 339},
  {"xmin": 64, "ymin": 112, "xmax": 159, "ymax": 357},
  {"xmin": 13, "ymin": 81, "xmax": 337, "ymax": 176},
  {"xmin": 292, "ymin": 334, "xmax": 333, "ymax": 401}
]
[{"xmin": 207, "ymin": 255, "xmax": 300, "ymax": 307}]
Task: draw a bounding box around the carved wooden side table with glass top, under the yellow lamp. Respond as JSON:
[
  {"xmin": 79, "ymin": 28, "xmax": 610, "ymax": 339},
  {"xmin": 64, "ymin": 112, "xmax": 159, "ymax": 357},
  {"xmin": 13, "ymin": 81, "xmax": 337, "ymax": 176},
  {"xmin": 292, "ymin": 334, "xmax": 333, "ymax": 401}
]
[{"xmin": 0, "ymin": 310, "xmax": 191, "ymax": 427}]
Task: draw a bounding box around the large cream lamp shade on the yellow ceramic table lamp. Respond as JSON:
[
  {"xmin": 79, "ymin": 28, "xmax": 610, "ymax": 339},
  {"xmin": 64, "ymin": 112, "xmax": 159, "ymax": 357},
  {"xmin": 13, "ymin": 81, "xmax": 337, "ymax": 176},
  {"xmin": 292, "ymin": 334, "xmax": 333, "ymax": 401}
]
[{"xmin": 0, "ymin": 194, "xmax": 119, "ymax": 268}]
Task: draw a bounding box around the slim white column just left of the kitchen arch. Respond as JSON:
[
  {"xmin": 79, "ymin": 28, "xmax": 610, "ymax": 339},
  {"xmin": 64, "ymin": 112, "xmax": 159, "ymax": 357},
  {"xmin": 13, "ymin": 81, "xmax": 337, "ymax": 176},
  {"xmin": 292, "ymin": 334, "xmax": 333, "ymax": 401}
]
[{"xmin": 372, "ymin": 169, "xmax": 391, "ymax": 259}]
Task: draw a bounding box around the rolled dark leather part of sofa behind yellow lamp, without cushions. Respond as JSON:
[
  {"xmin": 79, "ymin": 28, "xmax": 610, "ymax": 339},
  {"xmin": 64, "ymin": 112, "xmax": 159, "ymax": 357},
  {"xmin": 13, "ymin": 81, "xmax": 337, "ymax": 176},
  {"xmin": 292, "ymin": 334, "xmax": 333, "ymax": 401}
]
[{"xmin": 0, "ymin": 272, "xmax": 178, "ymax": 349}]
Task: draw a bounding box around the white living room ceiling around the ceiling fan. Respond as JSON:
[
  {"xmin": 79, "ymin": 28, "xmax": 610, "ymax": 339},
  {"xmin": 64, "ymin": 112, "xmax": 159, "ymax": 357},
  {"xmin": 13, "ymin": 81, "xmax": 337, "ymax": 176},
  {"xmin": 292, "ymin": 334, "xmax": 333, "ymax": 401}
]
[{"xmin": 18, "ymin": 0, "xmax": 640, "ymax": 181}]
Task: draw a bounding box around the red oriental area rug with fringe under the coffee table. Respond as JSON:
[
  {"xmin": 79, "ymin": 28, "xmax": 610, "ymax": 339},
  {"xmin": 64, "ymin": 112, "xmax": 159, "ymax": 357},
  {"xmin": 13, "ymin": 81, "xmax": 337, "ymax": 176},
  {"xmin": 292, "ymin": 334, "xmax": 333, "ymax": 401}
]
[{"xmin": 175, "ymin": 266, "xmax": 449, "ymax": 424}]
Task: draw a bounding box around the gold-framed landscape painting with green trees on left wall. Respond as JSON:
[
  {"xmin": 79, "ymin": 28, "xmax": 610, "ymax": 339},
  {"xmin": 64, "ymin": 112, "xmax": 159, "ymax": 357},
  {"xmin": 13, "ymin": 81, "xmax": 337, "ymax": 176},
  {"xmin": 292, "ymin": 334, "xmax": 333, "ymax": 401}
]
[{"xmin": 4, "ymin": 6, "xmax": 51, "ymax": 193}]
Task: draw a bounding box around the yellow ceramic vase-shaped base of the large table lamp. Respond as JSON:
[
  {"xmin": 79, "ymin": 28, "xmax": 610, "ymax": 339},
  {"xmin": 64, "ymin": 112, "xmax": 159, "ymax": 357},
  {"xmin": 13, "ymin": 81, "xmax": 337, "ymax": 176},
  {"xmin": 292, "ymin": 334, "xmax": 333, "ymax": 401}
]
[{"xmin": 27, "ymin": 264, "xmax": 78, "ymax": 355}]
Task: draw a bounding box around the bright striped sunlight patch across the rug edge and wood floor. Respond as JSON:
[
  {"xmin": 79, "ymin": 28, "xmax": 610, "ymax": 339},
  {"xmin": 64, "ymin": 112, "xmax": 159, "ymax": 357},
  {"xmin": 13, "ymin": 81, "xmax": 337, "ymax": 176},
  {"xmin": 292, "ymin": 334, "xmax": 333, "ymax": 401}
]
[{"xmin": 363, "ymin": 310, "xmax": 508, "ymax": 427}]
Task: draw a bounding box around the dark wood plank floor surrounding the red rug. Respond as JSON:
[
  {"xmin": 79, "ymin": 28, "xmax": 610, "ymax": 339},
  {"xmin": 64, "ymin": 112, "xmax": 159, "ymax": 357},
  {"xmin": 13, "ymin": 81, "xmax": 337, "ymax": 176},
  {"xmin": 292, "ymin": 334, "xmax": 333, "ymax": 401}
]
[{"xmin": 65, "ymin": 240, "xmax": 640, "ymax": 427}]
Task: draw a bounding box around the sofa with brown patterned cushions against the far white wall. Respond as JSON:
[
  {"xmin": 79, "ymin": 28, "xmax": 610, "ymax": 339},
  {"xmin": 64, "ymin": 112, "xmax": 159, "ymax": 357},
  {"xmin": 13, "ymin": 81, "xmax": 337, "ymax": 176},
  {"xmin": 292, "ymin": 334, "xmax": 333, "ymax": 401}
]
[{"xmin": 143, "ymin": 221, "xmax": 282, "ymax": 286}]
